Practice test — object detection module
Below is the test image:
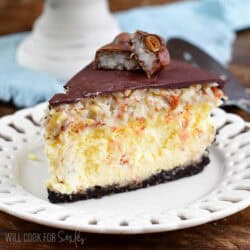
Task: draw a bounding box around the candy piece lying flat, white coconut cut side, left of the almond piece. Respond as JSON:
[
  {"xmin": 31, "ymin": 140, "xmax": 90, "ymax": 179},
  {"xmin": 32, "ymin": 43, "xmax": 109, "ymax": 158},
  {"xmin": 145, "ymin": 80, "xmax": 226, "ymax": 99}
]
[{"xmin": 94, "ymin": 32, "xmax": 139, "ymax": 70}]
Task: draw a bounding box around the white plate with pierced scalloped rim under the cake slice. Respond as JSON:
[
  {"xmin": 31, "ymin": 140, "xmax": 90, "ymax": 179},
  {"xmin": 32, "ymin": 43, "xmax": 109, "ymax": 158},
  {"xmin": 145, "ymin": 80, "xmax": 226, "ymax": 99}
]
[{"xmin": 0, "ymin": 104, "xmax": 250, "ymax": 234}]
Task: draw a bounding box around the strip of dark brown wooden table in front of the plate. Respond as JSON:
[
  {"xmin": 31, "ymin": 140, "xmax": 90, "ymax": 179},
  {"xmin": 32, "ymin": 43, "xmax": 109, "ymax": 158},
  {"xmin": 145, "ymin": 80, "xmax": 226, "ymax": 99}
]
[{"xmin": 0, "ymin": 209, "xmax": 250, "ymax": 250}]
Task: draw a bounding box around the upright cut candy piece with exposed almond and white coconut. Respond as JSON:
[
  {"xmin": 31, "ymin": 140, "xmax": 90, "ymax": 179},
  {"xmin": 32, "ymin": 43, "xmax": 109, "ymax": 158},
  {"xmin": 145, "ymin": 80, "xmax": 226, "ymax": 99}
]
[{"xmin": 131, "ymin": 31, "xmax": 170, "ymax": 78}]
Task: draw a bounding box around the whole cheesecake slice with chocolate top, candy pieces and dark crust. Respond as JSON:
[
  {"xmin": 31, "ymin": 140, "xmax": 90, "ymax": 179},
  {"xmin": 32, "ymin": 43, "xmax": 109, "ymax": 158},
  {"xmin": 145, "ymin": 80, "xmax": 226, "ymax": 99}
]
[{"xmin": 44, "ymin": 32, "xmax": 224, "ymax": 203}]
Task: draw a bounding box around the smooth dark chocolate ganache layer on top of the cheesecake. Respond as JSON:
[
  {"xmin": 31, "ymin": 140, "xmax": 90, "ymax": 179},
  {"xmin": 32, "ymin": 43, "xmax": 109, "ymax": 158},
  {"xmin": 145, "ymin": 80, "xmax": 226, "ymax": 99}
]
[{"xmin": 49, "ymin": 60, "xmax": 224, "ymax": 106}]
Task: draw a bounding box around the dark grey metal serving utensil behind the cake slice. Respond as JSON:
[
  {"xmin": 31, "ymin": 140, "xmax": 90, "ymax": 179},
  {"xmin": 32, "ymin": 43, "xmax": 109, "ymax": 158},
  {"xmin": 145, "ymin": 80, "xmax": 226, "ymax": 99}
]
[{"xmin": 167, "ymin": 38, "xmax": 250, "ymax": 114}]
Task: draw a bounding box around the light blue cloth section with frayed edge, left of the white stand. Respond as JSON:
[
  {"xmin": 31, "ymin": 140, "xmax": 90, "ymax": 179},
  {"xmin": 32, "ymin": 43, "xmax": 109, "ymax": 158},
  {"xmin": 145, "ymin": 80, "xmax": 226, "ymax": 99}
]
[{"xmin": 0, "ymin": 33, "xmax": 63, "ymax": 107}]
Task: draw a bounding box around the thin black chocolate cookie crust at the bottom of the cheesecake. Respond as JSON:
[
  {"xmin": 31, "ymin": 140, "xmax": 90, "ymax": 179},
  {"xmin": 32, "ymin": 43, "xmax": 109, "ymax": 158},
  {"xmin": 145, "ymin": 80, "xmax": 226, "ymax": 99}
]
[{"xmin": 48, "ymin": 154, "xmax": 210, "ymax": 203}]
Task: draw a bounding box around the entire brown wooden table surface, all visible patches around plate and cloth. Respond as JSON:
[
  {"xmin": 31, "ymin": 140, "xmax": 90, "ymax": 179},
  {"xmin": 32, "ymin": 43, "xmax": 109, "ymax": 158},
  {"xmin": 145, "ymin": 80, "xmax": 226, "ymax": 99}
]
[{"xmin": 0, "ymin": 0, "xmax": 250, "ymax": 250}]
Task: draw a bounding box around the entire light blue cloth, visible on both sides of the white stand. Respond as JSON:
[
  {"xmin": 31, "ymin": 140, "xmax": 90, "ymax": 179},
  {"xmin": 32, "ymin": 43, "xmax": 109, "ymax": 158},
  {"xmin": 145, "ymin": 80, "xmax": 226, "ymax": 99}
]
[{"xmin": 0, "ymin": 0, "xmax": 250, "ymax": 107}]
